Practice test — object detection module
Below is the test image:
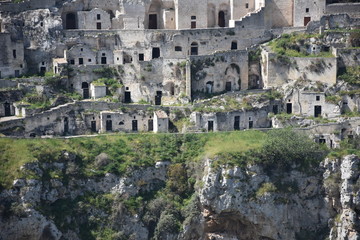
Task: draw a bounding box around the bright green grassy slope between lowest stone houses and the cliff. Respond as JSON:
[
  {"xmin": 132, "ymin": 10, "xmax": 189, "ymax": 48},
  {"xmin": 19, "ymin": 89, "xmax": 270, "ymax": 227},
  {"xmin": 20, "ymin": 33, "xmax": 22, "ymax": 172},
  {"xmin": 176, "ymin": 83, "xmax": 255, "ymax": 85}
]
[{"xmin": 0, "ymin": 131, "xmax": 266, "ymax": 188}]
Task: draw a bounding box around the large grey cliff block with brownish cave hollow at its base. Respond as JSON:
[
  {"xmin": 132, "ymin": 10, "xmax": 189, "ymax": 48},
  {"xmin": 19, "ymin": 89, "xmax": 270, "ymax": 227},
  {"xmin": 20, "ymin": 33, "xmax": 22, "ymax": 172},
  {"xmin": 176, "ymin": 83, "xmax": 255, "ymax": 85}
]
[{"xmin": 199, "ymin": 159, "xmax": 329, "ymax": 239}]
